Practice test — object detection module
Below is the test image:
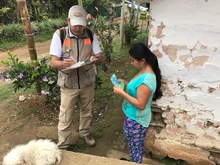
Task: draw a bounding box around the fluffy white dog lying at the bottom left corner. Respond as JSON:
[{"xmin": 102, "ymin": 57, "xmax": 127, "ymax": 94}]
[{"xmin": 2, "ymin": 139, "xmax": 62, "ymax": 165}]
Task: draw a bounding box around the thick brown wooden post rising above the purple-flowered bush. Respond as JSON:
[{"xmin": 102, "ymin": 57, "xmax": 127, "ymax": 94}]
[{"xmin": 17, "ymin": 0, "xmax": 37, "ymax": 60}]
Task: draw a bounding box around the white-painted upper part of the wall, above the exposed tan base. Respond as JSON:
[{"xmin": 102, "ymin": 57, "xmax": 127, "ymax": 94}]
[{"xmin": 149, "ymin": 0, "xmax": 220, "ymax": 122}]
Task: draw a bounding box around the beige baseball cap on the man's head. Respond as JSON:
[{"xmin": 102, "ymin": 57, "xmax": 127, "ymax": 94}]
[{"xmin": 68, "ymin": 5, "xmax": 86, "ymax": 26}]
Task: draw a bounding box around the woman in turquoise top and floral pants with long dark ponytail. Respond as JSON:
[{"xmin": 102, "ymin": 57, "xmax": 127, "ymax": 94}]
[{"xmin": 113, "ymin": 43, "xmax": 162, "ymax": 163}]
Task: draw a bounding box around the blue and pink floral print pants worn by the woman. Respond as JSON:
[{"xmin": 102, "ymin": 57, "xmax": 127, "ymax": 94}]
[{"xmin": 123, "ymin": 117, "xmax": 147, "ymax": 163}]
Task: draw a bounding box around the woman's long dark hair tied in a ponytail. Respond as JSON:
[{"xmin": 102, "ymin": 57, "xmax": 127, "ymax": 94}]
[{"xmin": 129, "ymin": 43, "xmax": 162, "ymax": 101}]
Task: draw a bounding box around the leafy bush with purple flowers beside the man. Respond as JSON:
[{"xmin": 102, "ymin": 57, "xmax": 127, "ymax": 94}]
[{"xmin": 1, "ymin": 51, "xmax": 60, "ymax": 105}]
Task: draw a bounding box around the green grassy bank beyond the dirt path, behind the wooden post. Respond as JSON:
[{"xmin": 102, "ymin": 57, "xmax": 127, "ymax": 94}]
[{"xmin": 0, "ymin": 18, "xmax": 67, "ymax": 51}]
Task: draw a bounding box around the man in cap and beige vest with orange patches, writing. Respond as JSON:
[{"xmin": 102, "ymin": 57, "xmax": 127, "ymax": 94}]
[{"xmin": 50, "ymin": 5, "xmax": 103, "ymax": 149}]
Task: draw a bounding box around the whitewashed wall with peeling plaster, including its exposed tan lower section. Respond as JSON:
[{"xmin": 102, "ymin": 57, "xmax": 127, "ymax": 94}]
[{"xmin": 146, "ymin": 0, "xmax": 220, "ymax": 164}]
